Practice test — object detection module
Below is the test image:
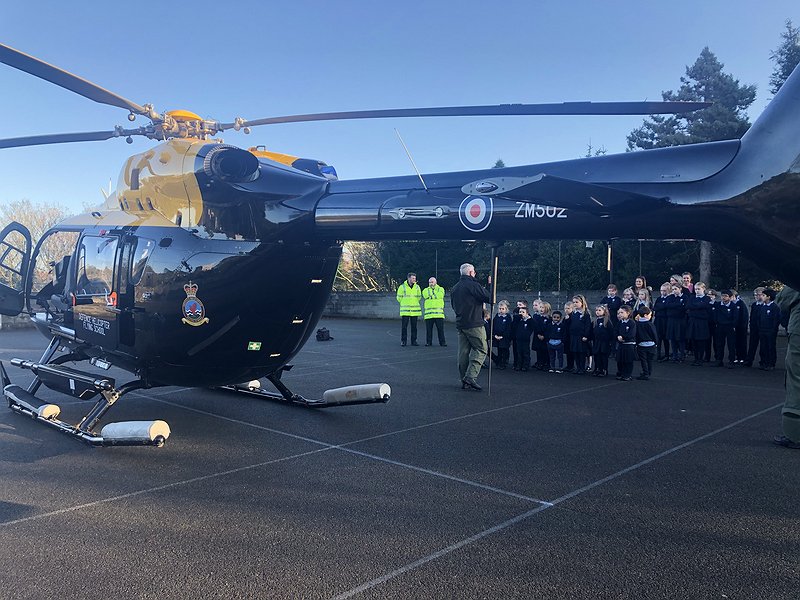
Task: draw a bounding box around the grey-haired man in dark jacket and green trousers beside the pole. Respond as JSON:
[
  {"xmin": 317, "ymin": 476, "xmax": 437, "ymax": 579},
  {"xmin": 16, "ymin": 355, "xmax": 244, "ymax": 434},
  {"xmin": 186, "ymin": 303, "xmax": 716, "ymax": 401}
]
[{"xmin": 450, "ymin": 263, "xmax": 492, "ymax": 390}]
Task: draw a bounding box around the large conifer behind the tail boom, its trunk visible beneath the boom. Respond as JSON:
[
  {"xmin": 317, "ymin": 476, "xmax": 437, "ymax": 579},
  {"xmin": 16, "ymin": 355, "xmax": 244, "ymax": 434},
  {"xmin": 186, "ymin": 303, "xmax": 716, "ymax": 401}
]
[{"xmin": 628, "ymin": 46, "xmax": 756, "ymax": 281}]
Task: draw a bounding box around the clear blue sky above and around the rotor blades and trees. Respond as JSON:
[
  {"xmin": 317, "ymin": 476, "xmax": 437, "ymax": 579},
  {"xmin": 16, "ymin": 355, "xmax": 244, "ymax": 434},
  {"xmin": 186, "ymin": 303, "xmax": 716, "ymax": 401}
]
[{"xmin": 0, "ymin": 0, "xmax": 800, "ymax": 212}]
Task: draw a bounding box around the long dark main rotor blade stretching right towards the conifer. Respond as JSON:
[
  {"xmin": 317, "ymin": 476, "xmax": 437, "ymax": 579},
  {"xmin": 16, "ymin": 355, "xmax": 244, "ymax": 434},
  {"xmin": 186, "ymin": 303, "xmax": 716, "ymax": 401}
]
[{"xmin": 220, "ymin": 102, "xmax": 711, "ymax": 130}]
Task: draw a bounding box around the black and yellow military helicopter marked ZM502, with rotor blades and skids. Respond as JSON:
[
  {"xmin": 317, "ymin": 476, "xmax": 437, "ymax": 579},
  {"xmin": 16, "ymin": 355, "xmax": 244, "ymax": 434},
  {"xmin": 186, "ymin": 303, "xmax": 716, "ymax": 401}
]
[{"xmin": 0, "ymin": 44, "xmax": 800, "ymax": 446}]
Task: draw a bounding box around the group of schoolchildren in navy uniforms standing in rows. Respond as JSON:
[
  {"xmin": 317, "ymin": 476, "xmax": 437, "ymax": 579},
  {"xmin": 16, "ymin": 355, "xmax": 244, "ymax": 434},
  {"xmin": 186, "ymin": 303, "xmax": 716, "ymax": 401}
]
[{"xmin": 484, "ymin": 273, "xmax": 781, "ymax": 381}]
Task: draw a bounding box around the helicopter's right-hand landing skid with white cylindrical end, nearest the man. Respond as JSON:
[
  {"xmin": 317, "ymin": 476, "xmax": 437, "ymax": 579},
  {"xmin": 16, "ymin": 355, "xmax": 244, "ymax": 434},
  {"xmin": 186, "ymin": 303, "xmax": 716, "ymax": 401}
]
[{"xmin": 219, "ymin": 372, "xmax": 392, "ymax": 408}]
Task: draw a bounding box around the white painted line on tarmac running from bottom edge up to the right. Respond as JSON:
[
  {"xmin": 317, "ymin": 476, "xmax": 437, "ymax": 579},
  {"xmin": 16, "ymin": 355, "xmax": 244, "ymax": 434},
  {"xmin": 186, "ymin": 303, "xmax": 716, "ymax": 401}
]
[{"xmin": 333, "ymin": 402, "xmax": 783, "ymax": 600}]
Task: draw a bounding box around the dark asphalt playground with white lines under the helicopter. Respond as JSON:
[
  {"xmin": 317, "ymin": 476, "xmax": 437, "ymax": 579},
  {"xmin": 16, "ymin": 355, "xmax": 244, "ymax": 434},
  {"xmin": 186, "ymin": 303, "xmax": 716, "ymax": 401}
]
[{"xmin": 0, "ymin": 320, "xmax": 800, "ymax": 600}]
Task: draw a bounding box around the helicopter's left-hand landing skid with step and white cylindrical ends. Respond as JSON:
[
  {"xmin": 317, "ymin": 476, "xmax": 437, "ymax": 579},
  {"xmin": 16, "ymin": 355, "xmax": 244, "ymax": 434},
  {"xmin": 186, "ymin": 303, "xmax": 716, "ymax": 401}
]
[{"xmin": 0, "ymin": 337, "xmax": 170, "ymax": 447}]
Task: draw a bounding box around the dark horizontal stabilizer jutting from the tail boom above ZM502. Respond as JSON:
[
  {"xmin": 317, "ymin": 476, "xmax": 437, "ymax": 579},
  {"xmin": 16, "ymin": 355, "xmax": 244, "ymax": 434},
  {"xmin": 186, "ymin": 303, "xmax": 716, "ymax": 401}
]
[{"xmin": 461, "ymin": 173, "xmax": 669, "ymax": 215}]
